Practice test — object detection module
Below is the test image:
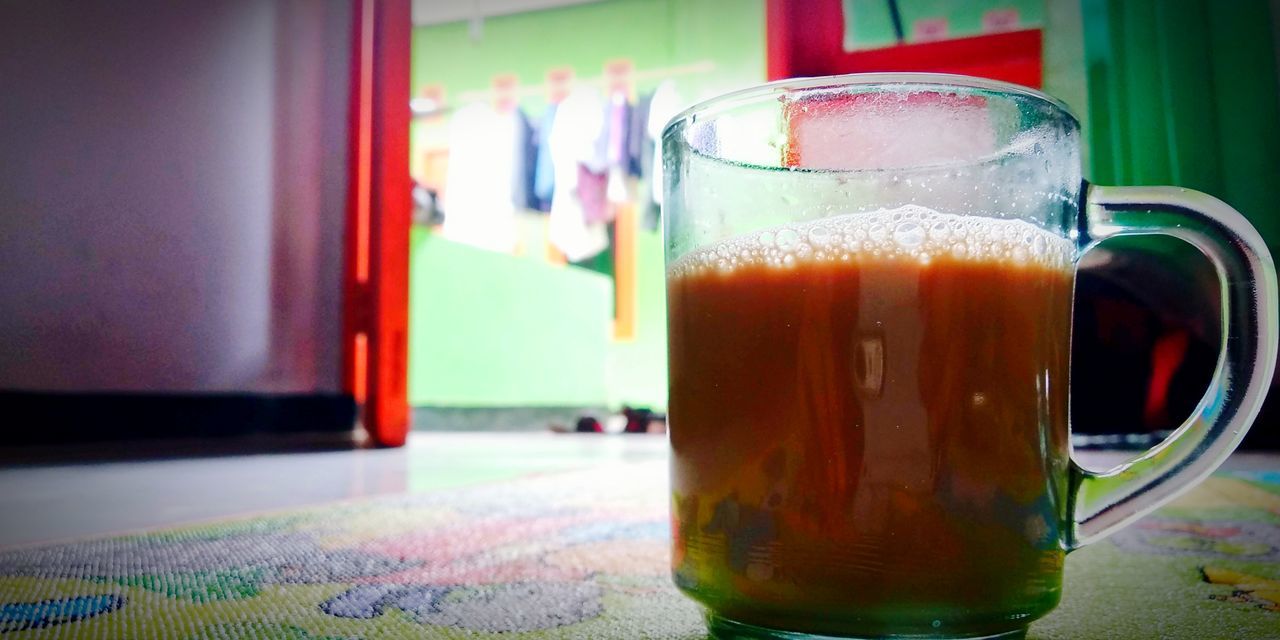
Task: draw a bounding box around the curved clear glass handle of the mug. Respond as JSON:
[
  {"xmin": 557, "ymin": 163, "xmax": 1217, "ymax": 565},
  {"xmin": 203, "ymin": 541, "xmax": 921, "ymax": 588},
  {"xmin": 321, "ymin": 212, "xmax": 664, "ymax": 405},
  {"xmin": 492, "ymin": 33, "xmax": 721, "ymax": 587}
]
[{"xmin": 1065, "ymin": 184, "xmax": 1277, "ymax": 550}]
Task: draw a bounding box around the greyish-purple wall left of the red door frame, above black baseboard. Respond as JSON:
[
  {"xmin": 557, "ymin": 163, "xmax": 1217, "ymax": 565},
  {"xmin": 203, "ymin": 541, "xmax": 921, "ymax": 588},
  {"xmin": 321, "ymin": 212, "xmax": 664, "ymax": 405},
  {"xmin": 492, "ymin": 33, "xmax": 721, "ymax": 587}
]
[{"xmin": 0, "ymin": 0, "xmax": 351, "ymax": 392}]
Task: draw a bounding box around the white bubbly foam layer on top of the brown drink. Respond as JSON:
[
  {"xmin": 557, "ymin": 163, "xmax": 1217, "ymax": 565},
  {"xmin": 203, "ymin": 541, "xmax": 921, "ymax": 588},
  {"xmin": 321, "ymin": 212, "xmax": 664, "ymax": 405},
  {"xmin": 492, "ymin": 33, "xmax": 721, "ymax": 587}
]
[{"xmin": 667, "ymin": 205, "xmax": 1075, "ymax": 278}]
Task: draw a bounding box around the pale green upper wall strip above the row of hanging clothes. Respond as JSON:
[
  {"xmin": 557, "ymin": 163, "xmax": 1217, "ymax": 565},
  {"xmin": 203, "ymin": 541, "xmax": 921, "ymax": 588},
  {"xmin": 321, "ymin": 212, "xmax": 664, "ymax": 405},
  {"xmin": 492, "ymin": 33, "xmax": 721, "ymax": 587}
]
[{"xmin": 411, "ymin": 0, "xmax": 764, "ymax": 111}]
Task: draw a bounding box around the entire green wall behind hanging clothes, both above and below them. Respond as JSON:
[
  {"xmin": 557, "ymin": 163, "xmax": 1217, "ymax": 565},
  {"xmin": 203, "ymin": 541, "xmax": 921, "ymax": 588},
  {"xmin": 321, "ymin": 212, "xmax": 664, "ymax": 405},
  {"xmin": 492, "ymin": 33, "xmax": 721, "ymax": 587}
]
[{"xmin": 410, "ymin": 0, "xmax": 764, "ymax": 410}]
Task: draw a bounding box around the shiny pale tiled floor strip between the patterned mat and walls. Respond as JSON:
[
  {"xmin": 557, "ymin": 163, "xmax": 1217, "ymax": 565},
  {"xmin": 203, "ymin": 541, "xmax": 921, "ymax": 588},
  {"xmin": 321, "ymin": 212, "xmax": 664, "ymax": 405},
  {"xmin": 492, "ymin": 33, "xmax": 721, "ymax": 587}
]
[{"xmin": 0, "ymin": 433, "xmax": 667, "ymax": 548}]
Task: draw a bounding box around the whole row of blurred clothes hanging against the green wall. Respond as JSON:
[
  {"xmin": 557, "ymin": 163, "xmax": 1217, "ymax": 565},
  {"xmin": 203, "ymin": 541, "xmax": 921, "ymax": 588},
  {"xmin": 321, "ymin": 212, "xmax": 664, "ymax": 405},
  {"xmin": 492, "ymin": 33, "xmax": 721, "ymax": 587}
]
[{"xmin": 443, "ymin": 82, "xmax": 680, "ymax": 256}]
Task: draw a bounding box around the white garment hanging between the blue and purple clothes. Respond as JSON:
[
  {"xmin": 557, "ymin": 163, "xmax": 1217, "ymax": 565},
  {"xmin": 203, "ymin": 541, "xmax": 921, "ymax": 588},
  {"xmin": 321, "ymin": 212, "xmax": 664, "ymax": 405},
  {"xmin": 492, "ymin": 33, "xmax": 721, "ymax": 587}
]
[{"xmin": 548, "ymin": 87, "xmax": 609, "ymax": 262}]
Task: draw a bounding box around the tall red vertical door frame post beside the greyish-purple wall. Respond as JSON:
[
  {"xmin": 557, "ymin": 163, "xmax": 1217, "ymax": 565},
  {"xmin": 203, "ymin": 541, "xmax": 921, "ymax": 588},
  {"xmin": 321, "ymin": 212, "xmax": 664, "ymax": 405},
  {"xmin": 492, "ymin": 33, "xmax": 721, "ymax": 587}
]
[{"xmin": 342, "ymin": 0, "xmax": 412, "ymax": 447}]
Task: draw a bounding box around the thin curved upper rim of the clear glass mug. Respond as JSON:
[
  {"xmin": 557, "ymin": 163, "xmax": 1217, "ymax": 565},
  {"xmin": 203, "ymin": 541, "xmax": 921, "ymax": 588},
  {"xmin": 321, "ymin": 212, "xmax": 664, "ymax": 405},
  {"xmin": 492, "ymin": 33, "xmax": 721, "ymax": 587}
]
[{"xmin": 662, "ymin": 72, "xmax": 1080, "ymax": 140}]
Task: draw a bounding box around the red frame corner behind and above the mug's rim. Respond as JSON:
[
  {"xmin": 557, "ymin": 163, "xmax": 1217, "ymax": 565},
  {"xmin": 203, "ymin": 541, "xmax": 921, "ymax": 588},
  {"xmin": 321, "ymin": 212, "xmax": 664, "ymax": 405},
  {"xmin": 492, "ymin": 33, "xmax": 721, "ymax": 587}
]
[{"xmin": 765, "ymin": 0, "xmax": 1043, "ymax": 88}]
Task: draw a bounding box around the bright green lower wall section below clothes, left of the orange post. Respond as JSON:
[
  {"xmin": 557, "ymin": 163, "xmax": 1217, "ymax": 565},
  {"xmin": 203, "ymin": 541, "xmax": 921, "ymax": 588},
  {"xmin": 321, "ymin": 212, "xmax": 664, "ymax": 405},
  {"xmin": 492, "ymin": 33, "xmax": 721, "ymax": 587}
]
[{"xmin": 408, "ymin": 229, "xmax": 613, "ymax": 407}]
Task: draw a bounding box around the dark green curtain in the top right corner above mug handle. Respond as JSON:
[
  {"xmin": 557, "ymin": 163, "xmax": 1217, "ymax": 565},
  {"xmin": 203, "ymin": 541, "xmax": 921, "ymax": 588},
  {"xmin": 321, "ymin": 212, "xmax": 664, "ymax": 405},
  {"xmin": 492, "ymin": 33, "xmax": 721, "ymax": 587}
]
[{"xmin": 1080, "ymin": 0, "xmax": 1280, "ymax": 255}]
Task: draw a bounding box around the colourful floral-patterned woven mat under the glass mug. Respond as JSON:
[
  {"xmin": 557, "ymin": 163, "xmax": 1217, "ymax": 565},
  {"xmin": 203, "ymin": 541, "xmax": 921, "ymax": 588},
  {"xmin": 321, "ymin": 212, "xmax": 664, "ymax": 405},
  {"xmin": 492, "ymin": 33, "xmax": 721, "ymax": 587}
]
[{"xmin": 0, "ymin": 465, "xmax": 1280, "ymax": 640}]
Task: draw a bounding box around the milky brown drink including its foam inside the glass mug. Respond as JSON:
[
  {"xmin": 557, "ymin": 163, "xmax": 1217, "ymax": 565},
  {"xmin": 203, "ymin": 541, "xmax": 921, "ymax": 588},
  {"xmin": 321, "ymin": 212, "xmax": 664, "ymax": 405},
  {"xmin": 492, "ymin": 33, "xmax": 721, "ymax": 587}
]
[{"xmin": 668, "ymin": 210, "xmax": 1074, "ymax": 635}]
